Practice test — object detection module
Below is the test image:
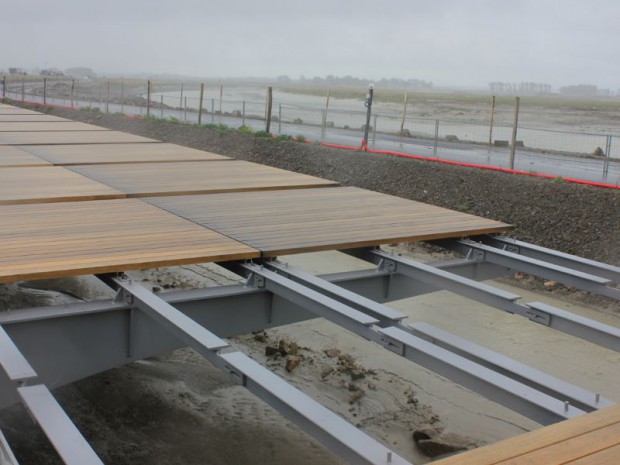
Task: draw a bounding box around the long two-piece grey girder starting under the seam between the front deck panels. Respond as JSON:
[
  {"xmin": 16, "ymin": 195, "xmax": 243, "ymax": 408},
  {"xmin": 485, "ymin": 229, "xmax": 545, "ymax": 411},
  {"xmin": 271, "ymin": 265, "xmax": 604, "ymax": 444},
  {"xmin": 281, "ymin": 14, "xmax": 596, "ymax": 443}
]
[{"xmin": 243, "ymin": 264, "xmax": 585, "ymax": 424}]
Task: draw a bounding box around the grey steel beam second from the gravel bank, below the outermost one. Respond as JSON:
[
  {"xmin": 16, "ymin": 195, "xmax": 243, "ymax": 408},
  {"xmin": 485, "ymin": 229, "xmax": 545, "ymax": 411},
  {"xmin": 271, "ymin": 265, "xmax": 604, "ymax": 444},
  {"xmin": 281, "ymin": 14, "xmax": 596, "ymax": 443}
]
[{"xmin": 436, "ymin": 239, "xmax": 620, "ymax": 299}]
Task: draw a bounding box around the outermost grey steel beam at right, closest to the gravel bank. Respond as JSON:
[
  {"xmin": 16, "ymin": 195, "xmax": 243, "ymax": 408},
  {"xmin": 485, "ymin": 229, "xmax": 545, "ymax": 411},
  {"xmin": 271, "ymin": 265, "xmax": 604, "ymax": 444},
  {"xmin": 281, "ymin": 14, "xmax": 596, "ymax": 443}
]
[{"xmin": 475, "ymin": 235, "xmax": 620, "ymax": 283}]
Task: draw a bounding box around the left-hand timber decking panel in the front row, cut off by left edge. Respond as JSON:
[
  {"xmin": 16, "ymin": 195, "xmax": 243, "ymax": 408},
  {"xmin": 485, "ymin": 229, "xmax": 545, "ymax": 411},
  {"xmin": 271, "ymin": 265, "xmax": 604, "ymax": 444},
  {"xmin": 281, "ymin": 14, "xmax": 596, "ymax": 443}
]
[{"xmin": 0, "ymin": 199, "xmax": 259, "ymax": 283}]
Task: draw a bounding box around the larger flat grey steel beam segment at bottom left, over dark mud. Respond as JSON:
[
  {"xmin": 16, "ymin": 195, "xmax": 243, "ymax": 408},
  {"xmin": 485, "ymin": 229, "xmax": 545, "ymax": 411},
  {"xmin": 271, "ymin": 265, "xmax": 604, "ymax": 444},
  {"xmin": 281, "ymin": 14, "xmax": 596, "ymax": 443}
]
[{"xmin": 17, "ymin": 384, "xmax": 103, "ymax": 465}]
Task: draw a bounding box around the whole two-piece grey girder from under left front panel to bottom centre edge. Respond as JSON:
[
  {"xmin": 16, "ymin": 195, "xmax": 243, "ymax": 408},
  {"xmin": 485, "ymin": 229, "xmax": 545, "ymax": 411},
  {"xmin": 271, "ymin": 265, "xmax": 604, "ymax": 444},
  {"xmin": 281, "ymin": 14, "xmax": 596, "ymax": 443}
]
[{"xmin": 114, "ymin": 279, "xmax": 409, "ymax": 465}]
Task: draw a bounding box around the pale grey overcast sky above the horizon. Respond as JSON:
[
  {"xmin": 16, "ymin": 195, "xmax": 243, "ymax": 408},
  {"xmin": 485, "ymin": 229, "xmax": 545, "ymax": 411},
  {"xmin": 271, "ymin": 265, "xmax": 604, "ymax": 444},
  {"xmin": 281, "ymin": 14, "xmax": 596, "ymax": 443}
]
[{"xmin": 0, "ymin": 0, "xmax": 620, "ymax": 90}]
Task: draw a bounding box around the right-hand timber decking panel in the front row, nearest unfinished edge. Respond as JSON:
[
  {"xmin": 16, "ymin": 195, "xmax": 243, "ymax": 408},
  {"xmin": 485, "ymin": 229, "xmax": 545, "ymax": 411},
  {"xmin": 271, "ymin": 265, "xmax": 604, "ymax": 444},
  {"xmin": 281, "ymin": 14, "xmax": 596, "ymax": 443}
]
[{"xmin": 147, "ymin": 187, "xmax": 510, "ymax": 257}]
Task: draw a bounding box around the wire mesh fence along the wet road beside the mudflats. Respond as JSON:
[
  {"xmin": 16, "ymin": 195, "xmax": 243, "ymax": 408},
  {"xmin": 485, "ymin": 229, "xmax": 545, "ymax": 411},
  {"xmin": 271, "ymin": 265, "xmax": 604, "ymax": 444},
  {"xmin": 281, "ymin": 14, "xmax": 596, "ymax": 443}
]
[{"xmin": 2, "ymin": 78, "xmax": 620, "ymax": 182}]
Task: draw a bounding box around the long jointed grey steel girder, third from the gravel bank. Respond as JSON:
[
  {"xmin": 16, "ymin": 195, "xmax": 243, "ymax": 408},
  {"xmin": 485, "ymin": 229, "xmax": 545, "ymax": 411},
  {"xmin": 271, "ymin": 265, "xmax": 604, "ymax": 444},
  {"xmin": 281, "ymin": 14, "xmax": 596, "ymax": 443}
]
[{"xmin": 348, "ymin": 249, "xmax": 620, "ymax": 351}]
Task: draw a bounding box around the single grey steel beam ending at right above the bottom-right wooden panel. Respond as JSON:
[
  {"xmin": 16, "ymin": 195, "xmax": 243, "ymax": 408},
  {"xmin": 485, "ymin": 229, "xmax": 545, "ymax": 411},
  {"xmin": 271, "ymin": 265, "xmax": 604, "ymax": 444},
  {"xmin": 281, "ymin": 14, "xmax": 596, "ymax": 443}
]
[{"xmin": 408, "ymin": 322, "xmax": 613, "ymax": 412}]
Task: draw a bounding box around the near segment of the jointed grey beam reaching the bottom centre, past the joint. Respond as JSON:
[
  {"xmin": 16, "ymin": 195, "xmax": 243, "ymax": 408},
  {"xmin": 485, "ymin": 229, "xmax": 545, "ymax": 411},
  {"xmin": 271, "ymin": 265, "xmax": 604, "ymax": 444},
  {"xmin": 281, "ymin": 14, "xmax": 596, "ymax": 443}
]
[{"xmin": 219, "ymin": 352, "xmax": 409, "ymax": 465}]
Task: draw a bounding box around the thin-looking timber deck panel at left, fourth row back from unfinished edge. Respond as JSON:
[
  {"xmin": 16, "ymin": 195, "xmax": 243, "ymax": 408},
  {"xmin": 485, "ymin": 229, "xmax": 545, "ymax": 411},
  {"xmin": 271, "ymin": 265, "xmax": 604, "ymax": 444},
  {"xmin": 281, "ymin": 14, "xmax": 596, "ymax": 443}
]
[{"xmin": 0, "ymin": 131, "xmax": 159, "ymax": 145}]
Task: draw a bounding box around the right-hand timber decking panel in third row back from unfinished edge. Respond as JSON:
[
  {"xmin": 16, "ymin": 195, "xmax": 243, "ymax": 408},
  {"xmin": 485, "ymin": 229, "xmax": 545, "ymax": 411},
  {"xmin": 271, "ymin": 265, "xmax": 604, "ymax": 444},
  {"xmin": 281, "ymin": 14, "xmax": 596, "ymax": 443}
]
[{"xmin": 20, "ymin": 143, "xmax": 230, "ymax": 166}]
